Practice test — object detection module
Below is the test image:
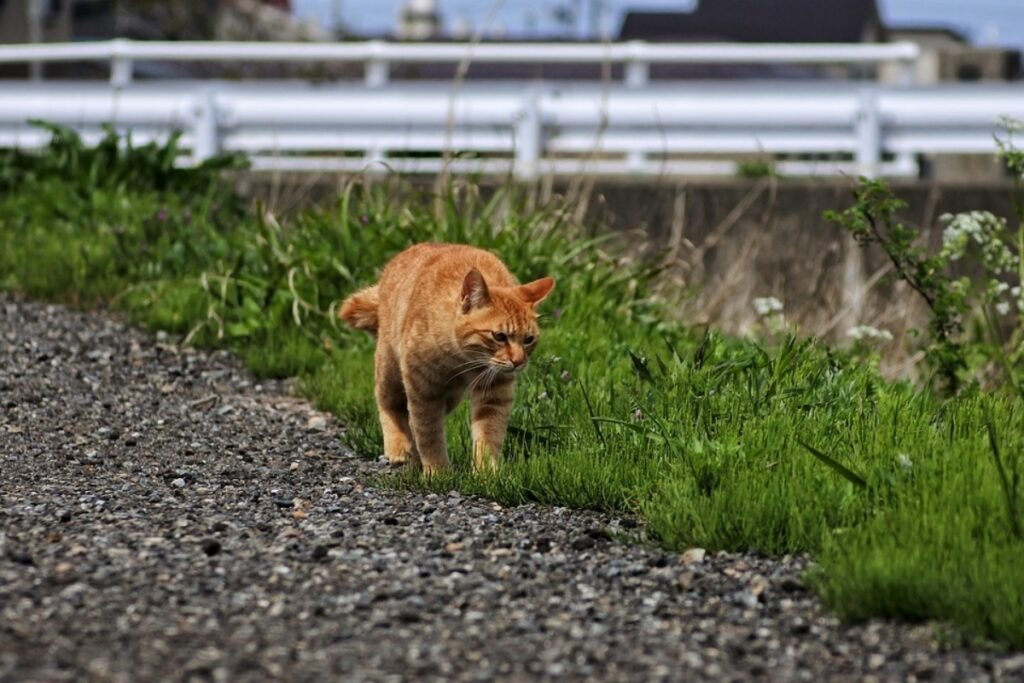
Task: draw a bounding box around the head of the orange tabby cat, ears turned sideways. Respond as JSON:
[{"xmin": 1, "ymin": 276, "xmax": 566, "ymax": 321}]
[{"xmin": 456, "ymin": 268, "xmax": 555, "ymax": 373}]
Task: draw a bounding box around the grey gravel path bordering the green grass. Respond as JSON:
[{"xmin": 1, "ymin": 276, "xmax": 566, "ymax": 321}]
[{"xmin": 0, "ymin": 295, "xmax": 1024, "ymax": 681}]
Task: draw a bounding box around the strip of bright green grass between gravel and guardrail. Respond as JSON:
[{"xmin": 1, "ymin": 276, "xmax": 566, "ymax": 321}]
[{"xmin": 6, "ymin": 124, "xmax": 1024, "ymax": 648}]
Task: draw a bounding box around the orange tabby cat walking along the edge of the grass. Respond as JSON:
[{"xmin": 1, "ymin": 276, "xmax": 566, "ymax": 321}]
[{"xmin": 339, "ymin": 244, "xmax": 555, "ymax": 473}]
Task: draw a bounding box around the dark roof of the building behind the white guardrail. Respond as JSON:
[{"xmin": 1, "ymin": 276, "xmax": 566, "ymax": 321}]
[{"xmin": 618, "ymin": 0, "xmax": 881, "ymax": 43}]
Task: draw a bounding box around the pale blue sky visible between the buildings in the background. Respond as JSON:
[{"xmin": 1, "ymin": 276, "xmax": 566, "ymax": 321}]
[{"xmin": 292, "ymin": 0, "xmax": 1024, "ymax": 48}]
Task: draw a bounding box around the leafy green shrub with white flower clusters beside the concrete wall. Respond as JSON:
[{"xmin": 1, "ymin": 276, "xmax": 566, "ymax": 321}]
[{"xmin": 825, "ymin": 120, "xmax": 1024, "ymax": 397}]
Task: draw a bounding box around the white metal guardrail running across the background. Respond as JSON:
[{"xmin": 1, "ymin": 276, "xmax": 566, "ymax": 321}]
[{"xmin": 0, "ymin": 41, "xmax": 1024, "ymax": 179}]
